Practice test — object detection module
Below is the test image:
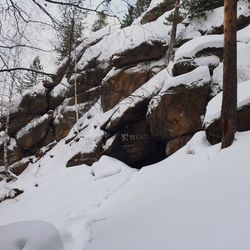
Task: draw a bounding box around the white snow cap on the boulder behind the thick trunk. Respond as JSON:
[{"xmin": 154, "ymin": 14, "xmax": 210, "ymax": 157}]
[{"xmin": 204, "ymin": 80, "xmax": 250, "ymax": 127}]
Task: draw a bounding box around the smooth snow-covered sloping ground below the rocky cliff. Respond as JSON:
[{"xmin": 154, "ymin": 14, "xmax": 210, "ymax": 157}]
[{"xmin": 0, "ymin": 132, "xmax": 250, "ymax": 250}]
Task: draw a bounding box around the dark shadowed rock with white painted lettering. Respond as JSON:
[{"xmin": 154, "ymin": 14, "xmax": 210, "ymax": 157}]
[{"xmin": 104, "ymin": 120, "xmax": 165, "ymax": 168}]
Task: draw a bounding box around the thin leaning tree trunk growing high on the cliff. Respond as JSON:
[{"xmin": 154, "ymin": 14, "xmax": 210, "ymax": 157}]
[{"xmin": 166, "ymin": 0, "xmax": 180, "ymax": 64}]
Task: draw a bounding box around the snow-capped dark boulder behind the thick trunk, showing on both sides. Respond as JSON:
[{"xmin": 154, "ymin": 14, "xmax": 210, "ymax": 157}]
[{"xmin": 204, "ymin": 81, "xmax": 250, "ymax": 144}]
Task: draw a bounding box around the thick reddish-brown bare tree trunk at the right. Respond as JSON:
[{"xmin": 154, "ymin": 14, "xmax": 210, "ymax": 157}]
[{"xmin": 221, "ymin": 0, "xmax": 237, "ymax": 148}]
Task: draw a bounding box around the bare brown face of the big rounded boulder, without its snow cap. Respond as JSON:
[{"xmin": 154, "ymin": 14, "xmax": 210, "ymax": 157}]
[{"xmin": 147, "ymin": 84, "xmax": 209, "ymax": 141}]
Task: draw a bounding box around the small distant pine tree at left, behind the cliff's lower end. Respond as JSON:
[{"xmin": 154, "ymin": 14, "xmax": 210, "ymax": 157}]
[{"xmin": 18, "ymin": 56, "xmax": 43, "ymax": 93}]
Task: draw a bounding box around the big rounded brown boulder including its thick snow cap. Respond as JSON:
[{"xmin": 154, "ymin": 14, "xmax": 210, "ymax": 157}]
[{"xmin": 147, "ymin": 66, "xmax": 210, "ymax": 141}]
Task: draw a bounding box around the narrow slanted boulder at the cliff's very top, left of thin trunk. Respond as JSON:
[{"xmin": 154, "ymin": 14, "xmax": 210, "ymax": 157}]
[{"xmin": 141, "ymin": 0, "xmax": 176, "ymax": 24}]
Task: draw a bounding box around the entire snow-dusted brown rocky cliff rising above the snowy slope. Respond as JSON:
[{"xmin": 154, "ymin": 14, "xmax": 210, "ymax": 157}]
[{"xmin": 0, "ymin": 0, "xmax": 250, "ymax": 174}]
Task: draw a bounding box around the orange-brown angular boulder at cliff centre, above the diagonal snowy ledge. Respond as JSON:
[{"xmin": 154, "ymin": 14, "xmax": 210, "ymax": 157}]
[{"xmin": 101, "ymin": 64, "xmax": 152, "ymax": 112}]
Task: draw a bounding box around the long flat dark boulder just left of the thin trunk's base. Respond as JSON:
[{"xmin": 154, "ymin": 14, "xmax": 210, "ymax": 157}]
[{"xmin": 112, "ymin": 40, "xmax": 167, "ymax": 68}]
